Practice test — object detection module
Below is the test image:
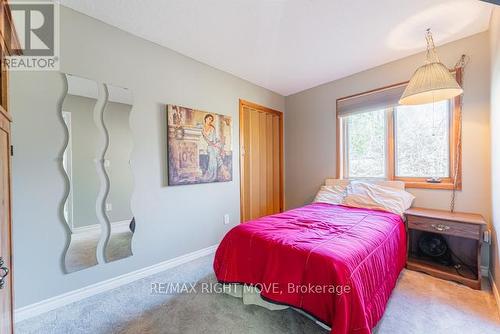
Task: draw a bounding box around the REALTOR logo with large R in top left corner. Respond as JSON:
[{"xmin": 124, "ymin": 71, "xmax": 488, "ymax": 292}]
[{"xmin": 4, "ymin": 1, "xmax": 59, "ymax": 71}]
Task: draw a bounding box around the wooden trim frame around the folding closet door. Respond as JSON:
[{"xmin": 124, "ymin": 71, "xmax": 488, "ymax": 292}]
[{"xmin": 239, "ymin": 99, "xmax": 285, "ymax": 224}]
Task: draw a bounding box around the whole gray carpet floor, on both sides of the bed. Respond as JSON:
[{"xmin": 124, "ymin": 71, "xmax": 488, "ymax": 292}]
[{"xmin": 16, "ymin": 256, "xmax": 500, "ymax": 334}]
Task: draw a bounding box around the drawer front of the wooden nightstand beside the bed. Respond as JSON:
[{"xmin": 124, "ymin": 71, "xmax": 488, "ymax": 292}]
[{"xmin": 407, "ymin": 215, "xmax": 481, "ymax": 240}]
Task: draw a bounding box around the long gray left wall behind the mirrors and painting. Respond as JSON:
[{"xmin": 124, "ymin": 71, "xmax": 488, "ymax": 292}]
[{"xmin": 10, "ymin": 7, "xmax": 286, "ymax": 307}]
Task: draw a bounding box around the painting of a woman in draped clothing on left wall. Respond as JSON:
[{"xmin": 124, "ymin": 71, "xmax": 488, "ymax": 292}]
[{"xmin": 167, "ymin": 104, "xmax": 233, "ymax": 185}]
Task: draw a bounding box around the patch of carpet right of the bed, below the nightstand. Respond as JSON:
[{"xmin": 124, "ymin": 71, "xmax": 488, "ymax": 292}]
[{"xmin": 374, "ymin": 270, "xmax": 500, "ymax": 334}]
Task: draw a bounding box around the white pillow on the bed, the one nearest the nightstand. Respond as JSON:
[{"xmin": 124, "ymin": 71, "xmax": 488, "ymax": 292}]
[{"xmin": 342, "ymin": 182, "xmax": 415, "ymax": 216}]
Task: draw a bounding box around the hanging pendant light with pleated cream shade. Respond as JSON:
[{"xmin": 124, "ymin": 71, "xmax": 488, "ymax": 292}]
[{"xmin": 399, "ymin": 29, "xmax": 463, "ymax": 105}]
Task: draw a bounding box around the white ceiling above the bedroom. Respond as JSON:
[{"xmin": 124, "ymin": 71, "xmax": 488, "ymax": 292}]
[{"xmin": 60, "ymin": 0, "xmax": 493, "ymax": 96}]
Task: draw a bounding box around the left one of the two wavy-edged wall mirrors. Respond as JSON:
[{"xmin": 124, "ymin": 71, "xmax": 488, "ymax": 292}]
[{"xmin": 62, "ymin": 75, "xmax": 102, "ymax": 273}]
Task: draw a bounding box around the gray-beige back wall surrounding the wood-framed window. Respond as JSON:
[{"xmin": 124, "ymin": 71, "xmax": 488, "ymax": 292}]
[{"xmin": 285, "ymin": 32, "xmax": 491, "ymax": 224}]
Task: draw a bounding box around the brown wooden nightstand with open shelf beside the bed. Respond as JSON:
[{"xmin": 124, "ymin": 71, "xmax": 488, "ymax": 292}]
[{"xmin": 405, "ymin": 208, "xmax": 487, "ymax": 290}]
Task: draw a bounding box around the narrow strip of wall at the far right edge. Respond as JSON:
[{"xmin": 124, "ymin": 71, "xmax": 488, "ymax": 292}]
[{"xmin": 490, "ymin": 7, "xmax": 500, "ymax": 289}]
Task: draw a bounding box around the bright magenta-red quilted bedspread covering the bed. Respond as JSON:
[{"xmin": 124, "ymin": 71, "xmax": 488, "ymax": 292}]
[{"xmin": 214, "ymin": 203, "xmax": 406, "ymax": 333}]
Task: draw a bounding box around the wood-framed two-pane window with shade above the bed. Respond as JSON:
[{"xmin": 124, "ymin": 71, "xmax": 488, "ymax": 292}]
[{"xmin": 337, "ymin": 70, "xmax": 461, "ymax": 189}]
